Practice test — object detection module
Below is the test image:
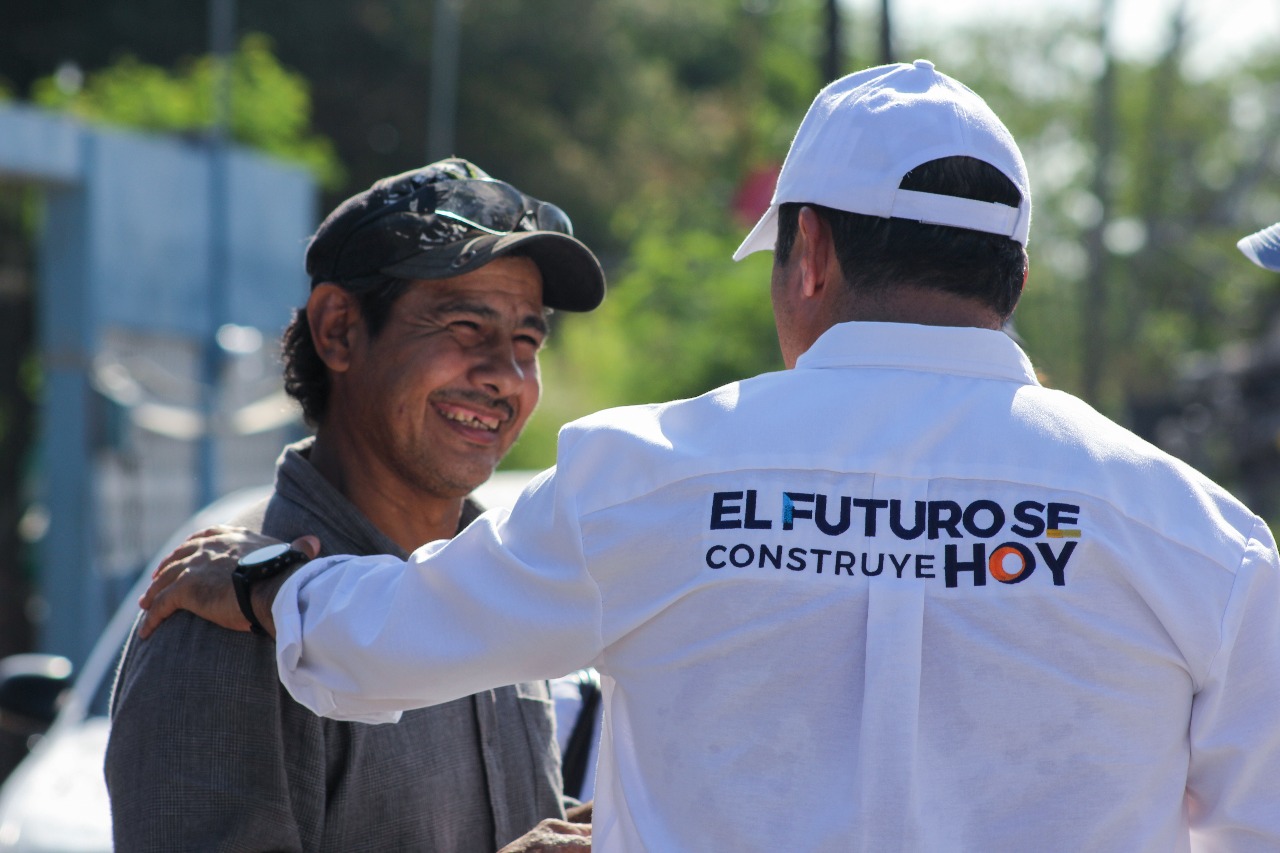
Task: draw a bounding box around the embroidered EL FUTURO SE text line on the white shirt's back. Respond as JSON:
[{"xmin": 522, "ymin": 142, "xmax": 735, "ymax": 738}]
[{"xmin": 710, "ymin": 489, "xmax": 1080, "ymax": 540}]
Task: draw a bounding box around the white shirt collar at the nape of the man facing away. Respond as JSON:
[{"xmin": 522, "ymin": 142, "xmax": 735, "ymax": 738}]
[{"xmin": 796, "ymin": 321, "xmax": 1039, "ymax": 386}]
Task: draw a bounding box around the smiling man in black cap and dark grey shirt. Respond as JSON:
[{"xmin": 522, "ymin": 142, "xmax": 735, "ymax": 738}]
[{"xmin": 106, "ymin": 159, "xmax": 604, "ymax": 853}]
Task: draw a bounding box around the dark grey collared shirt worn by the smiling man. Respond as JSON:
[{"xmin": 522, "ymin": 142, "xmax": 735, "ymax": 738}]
[{"xmin": 105, "ymin": 439, "xmax": 563, "ymax": 853}]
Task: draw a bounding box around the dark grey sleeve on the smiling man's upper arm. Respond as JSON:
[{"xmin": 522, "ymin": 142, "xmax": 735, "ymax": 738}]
[{"xmin": 104, "ymin": 613, "xmax": 312, "ymax": 852}]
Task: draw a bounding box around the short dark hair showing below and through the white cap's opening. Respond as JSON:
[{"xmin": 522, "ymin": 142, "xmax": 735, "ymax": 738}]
[{"xmin": 773, "ymin": 158, "xmax": 1027, "ymax": 320}]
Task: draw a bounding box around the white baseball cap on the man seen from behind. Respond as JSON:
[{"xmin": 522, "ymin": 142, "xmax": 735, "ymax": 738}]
[{"xmin": 733, "ymin": 59, "xmax": 1032, "ymax": 260}]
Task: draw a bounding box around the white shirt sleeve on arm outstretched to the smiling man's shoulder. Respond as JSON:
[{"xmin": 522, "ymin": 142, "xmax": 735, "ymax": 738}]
[{"xmin": 273, "ymin": 469, "xmax": 602, "ymax": 722}]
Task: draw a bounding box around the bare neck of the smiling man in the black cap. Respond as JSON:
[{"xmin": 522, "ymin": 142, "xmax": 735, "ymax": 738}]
[{"xmin": 308, "ymin": 428, "xmax": 463, "ymax": 551}]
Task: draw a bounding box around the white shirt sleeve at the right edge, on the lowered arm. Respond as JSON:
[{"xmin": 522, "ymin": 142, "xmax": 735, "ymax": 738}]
[{"xmin": 1187, "ymin": 521, "xmax": 1280, "ymax": 853}]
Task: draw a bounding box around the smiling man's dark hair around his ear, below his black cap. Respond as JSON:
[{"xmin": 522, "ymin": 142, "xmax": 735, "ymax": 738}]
[{"xmin": 280, "ymin": 275, "xmax": 411, "ymax": 427}]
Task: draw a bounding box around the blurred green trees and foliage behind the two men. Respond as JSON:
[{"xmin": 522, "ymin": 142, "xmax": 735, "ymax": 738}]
[{"xmin": 0, "ymin": 0, "xmax": 1280, "ymax": 499}]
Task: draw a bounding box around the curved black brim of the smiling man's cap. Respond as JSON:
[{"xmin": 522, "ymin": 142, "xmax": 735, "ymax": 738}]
[{"xmin": 380, "ymin": 231, "xmax": 604, "ymax": 311}]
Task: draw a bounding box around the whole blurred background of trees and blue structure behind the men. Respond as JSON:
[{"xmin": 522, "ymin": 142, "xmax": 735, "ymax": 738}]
[{"xmin": 0, "ymin": 0, "xmax": 1280, "ymax": 783}]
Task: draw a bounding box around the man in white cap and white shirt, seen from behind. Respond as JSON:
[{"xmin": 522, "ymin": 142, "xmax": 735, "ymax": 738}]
[{"xmin": 143, "ymin": 61, "xmax": 1280, "ymax": 853}]
